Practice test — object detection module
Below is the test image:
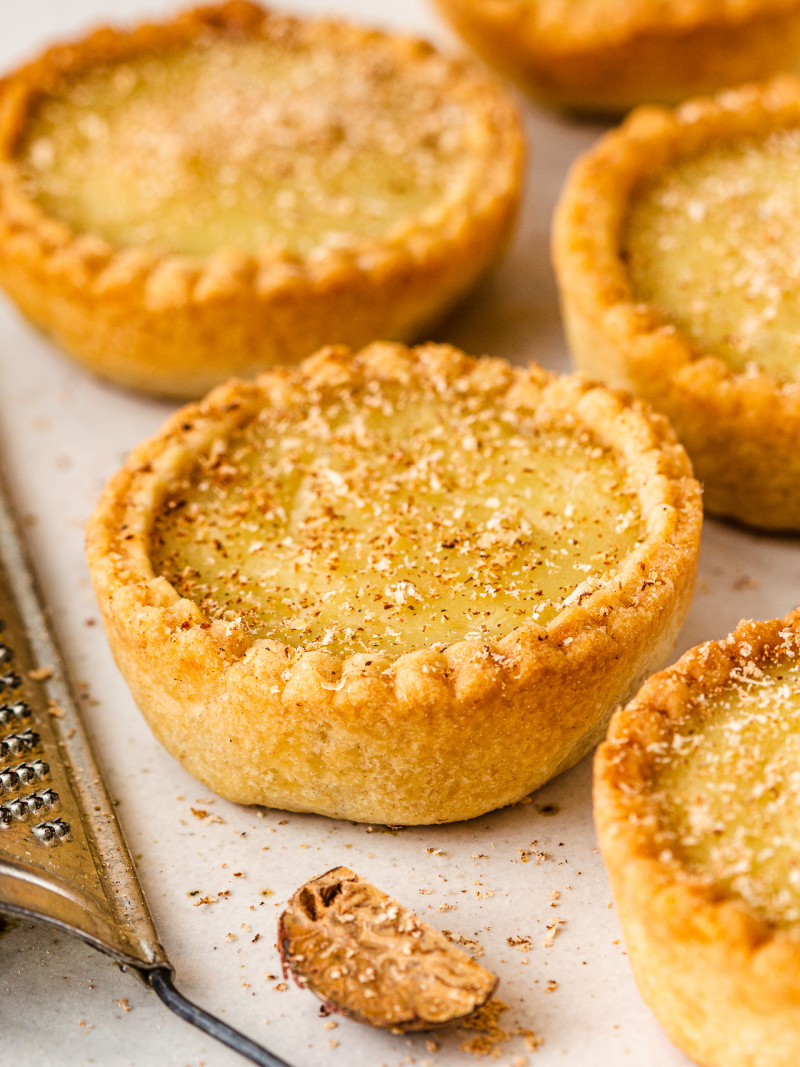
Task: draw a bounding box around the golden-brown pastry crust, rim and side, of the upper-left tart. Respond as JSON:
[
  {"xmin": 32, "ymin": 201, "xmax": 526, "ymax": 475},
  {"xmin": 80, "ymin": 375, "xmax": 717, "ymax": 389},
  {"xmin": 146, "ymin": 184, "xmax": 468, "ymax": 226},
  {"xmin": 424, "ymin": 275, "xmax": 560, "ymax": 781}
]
[{"xmin": 0, "ymin": 0, "xmax": 525, "ymax": 398}]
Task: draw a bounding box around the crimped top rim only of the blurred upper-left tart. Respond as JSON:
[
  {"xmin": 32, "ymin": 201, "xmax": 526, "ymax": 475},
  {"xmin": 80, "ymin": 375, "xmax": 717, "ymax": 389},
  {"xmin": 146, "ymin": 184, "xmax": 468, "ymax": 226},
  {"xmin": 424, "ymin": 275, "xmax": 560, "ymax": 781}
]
[{"xmin": 0, "ymin": 0, "xmax": 525, "ymax": 308}]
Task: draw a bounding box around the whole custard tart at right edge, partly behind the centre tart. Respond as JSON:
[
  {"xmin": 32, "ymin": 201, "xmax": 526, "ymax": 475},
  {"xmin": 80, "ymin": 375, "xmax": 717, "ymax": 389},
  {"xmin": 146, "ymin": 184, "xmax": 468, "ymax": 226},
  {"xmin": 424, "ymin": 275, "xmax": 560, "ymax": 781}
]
[{"xmin": 554, "ymin": 76, "xmax": 800, "ymax": 530}]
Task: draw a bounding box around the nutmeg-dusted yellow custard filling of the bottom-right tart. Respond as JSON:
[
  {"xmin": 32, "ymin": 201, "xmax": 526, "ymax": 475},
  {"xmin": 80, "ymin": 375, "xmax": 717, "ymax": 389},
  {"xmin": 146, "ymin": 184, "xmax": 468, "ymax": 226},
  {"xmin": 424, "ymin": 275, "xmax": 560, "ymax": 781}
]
[{"xmin": 656, "ymin": 662, "xmax": 800, "ymax": 924}]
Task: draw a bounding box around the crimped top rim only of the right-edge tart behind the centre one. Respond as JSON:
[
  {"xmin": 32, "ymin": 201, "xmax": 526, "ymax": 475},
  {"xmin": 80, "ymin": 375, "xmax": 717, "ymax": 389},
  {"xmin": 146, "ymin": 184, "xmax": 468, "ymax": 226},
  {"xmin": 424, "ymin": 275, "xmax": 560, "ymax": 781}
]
[{"xmin": 553, "ymin": 75, "xmax": 800, "ymax": 411}]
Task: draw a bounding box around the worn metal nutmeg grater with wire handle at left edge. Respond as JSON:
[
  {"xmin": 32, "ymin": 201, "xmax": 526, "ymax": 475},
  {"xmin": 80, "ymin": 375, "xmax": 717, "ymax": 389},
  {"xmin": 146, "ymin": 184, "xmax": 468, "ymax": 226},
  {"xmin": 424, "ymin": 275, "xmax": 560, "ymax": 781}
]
[{"xmin": 0, "ymin": 487, "xmax": 288, "ymax": 1067}]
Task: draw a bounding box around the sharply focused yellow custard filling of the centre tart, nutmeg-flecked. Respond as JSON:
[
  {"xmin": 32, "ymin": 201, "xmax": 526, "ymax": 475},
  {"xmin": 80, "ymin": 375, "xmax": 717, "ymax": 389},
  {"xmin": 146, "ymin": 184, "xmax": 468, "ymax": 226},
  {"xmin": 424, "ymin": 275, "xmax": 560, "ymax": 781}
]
[{"xmin": 149, "ymin": 382, "xmax": 643, "ymax": 654}]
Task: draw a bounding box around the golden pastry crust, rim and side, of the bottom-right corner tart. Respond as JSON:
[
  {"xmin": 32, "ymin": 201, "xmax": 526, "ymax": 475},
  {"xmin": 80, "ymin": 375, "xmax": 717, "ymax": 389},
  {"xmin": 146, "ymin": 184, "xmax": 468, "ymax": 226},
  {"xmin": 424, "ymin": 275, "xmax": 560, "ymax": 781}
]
[{"xmin": 594, "ymin": 610, "xmax": 800, "ymax": 1067}]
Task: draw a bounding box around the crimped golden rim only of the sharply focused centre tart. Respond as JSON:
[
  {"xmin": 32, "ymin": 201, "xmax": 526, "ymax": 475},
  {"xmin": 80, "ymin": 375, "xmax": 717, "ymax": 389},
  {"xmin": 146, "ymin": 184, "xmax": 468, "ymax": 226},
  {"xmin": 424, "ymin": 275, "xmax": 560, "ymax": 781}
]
[{"xmin": 87, "ymin": 343, "xmax": 701, "ymax": 706}]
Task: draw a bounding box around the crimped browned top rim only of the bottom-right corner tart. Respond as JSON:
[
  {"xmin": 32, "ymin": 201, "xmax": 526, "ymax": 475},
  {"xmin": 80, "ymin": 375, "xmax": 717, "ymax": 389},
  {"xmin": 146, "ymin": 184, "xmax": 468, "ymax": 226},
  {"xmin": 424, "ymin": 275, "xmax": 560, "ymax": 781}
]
[{"xmin": 594, "ymin": 608, "xmax": 800, "ymax": 981}]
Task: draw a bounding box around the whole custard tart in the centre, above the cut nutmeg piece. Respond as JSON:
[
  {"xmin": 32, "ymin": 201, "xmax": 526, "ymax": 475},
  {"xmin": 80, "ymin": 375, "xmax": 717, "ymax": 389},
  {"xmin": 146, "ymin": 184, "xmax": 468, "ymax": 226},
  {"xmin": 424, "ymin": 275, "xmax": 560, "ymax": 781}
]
[{"xmin": 87, "ymin": 343, "xmax": 702, "ymax": 824}]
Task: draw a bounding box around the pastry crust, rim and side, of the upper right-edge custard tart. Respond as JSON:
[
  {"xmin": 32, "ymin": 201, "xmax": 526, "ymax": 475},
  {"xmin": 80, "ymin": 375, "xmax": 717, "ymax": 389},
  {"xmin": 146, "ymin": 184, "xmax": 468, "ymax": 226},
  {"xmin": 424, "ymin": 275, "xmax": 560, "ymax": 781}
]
[{"xmin": 554, "ymin": 76, "xmax": 800, "ymax": 530}]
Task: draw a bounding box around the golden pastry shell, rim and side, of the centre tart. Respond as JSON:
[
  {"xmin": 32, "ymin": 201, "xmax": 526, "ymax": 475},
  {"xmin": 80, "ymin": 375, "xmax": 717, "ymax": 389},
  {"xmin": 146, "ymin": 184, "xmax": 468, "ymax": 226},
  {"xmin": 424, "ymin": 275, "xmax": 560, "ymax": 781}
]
[{"xmin": 87, "ymin": 344, "xmax": 701, "ymax": 824}]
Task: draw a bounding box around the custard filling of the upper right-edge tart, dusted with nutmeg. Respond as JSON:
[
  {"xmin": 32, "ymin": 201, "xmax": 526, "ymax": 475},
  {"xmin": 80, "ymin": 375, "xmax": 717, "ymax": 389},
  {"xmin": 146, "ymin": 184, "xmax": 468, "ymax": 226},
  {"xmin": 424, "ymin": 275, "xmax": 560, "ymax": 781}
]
[{"xmin": 622, "ymin": 129, "xmax": 800, "ymax": 381}]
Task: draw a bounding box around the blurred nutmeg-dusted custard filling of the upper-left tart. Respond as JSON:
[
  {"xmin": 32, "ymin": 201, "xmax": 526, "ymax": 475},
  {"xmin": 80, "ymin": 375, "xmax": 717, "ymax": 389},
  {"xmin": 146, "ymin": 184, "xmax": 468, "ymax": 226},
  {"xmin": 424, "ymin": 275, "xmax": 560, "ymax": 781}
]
[{"xmin": 17, "ymin": 35, "xmax": 469, "ymax": 256}]
